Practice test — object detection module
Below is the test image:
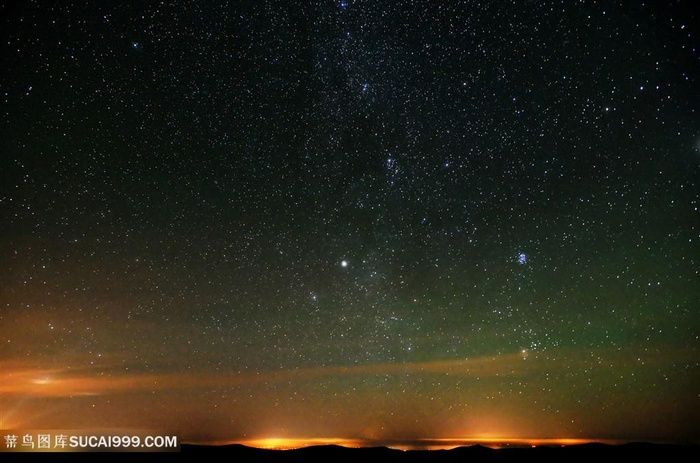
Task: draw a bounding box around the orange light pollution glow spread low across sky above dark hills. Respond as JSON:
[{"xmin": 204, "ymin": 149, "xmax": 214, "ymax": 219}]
[{"xmin": 0, "ymin": 351, "xmax": 688, "ymax": 449}]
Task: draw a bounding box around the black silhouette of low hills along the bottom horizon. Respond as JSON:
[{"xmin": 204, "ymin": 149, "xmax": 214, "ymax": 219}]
[{"xmin": 0, "ymin": 443, "xmax": 699, "ymax": 463}]
